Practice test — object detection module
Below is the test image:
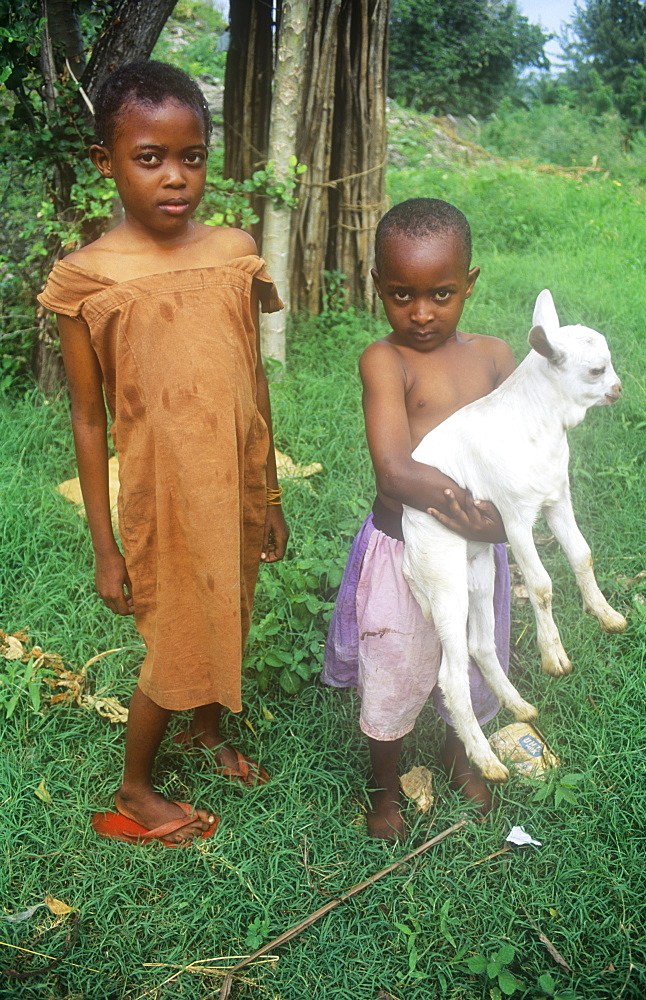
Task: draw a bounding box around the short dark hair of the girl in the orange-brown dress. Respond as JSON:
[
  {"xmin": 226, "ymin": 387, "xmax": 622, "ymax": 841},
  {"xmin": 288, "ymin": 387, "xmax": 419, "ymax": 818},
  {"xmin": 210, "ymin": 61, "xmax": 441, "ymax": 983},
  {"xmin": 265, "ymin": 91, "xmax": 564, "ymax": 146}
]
[{"xmin": 94, "ymin": 59, "xmax": 213, "ymax": 146}]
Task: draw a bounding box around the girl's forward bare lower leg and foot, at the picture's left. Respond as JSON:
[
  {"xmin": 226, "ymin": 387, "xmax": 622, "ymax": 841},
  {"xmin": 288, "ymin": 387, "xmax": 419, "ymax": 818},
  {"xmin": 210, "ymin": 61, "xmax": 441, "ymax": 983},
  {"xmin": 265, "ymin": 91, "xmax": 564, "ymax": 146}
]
[{"xmin": 115, "ymin": 687, "xmax": 215, "ymax": 842}]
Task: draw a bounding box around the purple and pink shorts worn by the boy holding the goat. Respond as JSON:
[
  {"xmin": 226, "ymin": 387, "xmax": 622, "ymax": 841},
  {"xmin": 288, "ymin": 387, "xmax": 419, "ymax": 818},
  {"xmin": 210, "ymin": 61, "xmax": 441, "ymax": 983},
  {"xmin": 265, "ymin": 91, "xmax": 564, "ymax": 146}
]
[{"xmin": 322, "ymin": 514, "xmax": 510, "ymax": 740}]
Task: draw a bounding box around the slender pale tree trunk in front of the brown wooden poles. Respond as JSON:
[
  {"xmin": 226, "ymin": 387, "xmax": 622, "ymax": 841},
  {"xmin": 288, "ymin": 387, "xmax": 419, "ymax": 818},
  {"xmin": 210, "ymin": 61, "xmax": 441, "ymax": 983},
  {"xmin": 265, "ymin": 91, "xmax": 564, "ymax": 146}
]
[{"xmin": 262, "ymin": 0, "xmax": 308, "ymax": 362}]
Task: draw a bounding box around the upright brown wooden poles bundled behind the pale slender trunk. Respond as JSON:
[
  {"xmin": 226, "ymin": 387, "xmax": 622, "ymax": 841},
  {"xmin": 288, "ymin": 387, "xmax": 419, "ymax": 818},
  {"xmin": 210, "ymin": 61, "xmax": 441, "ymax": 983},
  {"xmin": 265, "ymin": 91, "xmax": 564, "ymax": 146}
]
[{"xmin": 225, "ymin": 0, "xmax": 388, "ymax": 338}]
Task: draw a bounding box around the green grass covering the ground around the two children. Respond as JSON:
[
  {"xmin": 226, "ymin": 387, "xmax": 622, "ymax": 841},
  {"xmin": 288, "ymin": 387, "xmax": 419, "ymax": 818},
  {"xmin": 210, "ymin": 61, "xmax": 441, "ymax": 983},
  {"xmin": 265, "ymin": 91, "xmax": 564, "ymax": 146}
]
[{"xmin": 0, "ymin": 154, "xmax": 646, "ymax": 1000}]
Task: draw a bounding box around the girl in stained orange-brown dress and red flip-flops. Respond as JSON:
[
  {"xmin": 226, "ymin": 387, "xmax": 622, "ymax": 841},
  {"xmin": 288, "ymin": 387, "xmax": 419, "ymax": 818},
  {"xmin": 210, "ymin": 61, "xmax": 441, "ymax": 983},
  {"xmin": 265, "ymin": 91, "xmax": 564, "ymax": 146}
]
[{"xmin": 40, "ymin": 62, "xmax": 288, "ymax": 846}]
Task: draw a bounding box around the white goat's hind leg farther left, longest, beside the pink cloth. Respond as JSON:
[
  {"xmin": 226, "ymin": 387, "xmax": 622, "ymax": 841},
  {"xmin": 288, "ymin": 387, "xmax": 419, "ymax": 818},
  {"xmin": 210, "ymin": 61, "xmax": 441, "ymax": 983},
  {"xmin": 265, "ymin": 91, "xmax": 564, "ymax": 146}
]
[{"xmin": 403, "ymin": 511, "xmax": 509, "ymax": 782}]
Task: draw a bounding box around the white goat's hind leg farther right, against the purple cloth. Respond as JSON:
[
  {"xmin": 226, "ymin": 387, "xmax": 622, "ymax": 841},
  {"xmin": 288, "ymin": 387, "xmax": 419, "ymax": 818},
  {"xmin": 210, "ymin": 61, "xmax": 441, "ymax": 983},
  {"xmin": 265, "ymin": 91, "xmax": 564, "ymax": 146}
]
[{"xmin": 467, "ymin": 543, "xmax": 538, "ymax": 722}]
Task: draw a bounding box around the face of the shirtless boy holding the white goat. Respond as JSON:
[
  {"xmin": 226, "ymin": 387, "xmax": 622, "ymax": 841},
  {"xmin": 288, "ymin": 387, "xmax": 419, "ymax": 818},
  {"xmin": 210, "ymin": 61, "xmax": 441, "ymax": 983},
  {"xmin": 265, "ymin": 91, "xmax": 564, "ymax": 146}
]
[{"xmin": 372, "ymin": 233, "xmax": 480, "ymax": 352}]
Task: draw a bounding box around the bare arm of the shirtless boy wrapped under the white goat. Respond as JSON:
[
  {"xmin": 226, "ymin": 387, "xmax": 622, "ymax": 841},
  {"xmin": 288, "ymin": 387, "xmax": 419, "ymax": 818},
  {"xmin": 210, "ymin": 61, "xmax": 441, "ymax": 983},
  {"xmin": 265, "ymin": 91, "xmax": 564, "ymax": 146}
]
[{"xmin": 359, "ymin": 341, "xmax": 505, "ymax": 542}]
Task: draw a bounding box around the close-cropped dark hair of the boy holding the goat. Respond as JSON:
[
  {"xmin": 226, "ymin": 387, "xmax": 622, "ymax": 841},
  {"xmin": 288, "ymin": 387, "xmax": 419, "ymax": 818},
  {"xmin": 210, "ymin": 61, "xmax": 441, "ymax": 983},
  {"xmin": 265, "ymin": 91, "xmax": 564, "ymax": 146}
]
[{"xmin": 375, "ymin": 198, "xmax": 471, "ymax": 271}]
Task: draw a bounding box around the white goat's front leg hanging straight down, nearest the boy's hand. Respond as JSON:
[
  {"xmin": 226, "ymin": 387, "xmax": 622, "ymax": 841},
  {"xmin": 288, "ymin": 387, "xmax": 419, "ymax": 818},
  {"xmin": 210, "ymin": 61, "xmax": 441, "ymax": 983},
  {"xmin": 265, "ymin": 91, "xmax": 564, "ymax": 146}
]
[{"xmin": 505, "ymin": 518, "xmax": 572, "ymax": 677}]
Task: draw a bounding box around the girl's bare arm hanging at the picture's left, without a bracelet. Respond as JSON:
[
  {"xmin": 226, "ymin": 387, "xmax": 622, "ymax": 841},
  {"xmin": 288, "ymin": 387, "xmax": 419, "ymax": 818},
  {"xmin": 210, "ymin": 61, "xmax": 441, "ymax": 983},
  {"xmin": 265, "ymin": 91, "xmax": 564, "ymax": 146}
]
[{"xmin": 58, "ymin": 315, "xmax": 134, "ymax": 615}]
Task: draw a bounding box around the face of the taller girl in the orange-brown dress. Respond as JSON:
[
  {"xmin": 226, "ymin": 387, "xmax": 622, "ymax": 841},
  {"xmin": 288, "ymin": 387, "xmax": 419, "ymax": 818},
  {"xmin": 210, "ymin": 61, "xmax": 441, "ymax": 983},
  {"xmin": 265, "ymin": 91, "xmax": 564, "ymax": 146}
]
[{"xmin": 90, "ymin": 99, "xmax": 208, "ymax": 237}]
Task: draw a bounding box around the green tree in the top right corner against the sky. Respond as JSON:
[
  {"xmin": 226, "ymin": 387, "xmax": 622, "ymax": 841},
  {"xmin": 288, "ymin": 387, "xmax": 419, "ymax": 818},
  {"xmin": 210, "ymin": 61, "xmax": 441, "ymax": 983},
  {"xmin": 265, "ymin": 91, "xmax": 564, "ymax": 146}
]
[{"xmin": 567, "ymin": 0, "xmax": 646, "ymax": 128}]
